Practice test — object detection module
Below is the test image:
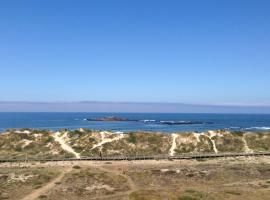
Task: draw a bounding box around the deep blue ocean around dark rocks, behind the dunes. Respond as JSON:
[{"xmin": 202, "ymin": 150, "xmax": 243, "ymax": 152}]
[{"xmin": 0, "ymin": 113, "xmax": 270, "ymax": 132}]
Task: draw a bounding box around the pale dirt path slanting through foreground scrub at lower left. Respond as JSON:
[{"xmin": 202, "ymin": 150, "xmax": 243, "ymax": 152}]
[{"xmin": 22, "ymin": 167, "xmax": 72, "ymax": 200}]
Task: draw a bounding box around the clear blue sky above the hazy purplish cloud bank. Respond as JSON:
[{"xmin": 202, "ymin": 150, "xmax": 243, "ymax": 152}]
[{"xmin": 0, "ymin": 0, "xmax": 270, "ymax": 105}]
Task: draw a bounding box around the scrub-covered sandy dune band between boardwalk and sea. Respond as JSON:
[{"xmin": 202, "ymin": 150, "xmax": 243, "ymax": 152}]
[{"xmin": 0, "ymin": 129, "xmax": 270, "ymax": 158}]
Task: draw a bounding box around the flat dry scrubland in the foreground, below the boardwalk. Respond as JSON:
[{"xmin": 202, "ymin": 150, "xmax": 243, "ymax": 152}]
[{"xmin": 0, "ymin": 157, "xmax": 270, "ymax": 200}]
